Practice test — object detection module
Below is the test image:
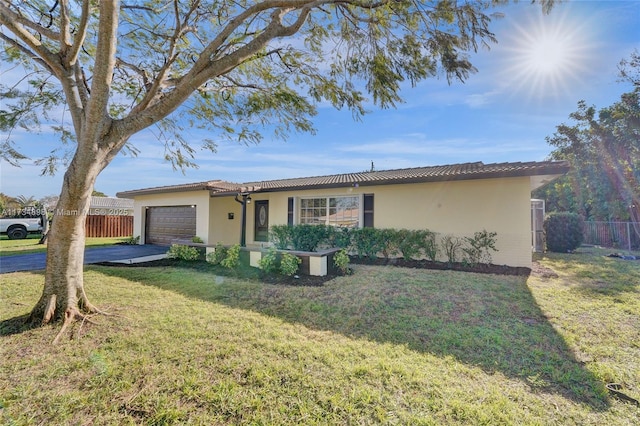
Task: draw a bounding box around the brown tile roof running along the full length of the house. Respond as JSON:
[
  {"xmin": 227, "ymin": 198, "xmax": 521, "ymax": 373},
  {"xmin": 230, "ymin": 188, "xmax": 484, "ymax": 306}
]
[{"xmin": 117, "ymin": 161, "xmax": 569, "ymax": 197}]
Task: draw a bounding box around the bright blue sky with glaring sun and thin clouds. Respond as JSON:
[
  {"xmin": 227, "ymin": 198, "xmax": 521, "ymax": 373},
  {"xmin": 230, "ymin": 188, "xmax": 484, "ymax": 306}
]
[{"xmin": 0, "ymin": 1, "xmax": 640, "ymax": 198}]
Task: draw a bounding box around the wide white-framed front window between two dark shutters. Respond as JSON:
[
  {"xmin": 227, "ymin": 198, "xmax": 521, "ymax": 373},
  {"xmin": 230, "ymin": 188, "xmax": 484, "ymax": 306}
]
[{"xmin": 300, "ymin": 196, "xmax": 361, "ymax": 228}]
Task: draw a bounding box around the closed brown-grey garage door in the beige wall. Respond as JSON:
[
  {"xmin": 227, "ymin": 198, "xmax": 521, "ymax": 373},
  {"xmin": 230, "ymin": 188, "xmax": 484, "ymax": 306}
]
[{"xmin": 145, "ymin": 206, "xmax": 196, "ymax": 246}]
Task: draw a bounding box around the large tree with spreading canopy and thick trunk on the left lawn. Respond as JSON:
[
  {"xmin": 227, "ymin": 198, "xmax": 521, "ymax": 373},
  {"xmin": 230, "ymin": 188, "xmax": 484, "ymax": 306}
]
[{"xmin": 0, "ymin": 0, "xmax": 551, "ymax": 332}]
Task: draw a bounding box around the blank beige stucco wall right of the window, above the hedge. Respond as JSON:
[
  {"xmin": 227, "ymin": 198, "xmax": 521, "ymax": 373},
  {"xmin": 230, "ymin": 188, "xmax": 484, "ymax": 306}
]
[{"xmin": 374, "ymin": 177, "xmax": 531, "ymax": 267}]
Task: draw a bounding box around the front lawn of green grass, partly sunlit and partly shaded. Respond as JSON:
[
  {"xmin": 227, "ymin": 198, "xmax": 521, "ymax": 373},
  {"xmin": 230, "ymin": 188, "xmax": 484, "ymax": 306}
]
[{"xmin": 0, "ymin": 248, "xmax": 640, "ymax": 425}]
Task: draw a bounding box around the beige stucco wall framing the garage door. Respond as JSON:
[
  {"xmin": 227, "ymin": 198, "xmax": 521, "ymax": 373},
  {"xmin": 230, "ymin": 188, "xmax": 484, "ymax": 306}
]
[{"xmin": 133, "ymin": 191, "xmax": 210, "ymax": 244}]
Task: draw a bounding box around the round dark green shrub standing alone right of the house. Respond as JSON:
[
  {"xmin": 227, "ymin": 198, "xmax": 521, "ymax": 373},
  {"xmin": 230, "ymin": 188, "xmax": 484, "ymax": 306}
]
[{"xmin": 543, "ymin": 212, "xmax": 584, "ymax": 253}]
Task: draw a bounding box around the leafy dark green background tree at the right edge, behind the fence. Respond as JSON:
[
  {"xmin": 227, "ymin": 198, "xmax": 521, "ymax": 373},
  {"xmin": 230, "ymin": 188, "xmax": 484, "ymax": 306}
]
[{"xmin": 534, "ymin": 52, "xmax": 640, "ymax": 226}]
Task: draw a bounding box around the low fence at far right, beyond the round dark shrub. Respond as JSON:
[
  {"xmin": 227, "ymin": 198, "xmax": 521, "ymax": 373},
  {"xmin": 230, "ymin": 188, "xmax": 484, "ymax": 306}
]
[{"xmin": 583, "ymin": 222, "xmax": 640, "ymax": 250}]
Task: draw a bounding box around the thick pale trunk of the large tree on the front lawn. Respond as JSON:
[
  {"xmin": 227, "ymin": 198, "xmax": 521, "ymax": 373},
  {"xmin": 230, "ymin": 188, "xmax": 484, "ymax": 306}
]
[{"xmin": 30, "ymin": 154, "xmax": 100, "ymax": 325}]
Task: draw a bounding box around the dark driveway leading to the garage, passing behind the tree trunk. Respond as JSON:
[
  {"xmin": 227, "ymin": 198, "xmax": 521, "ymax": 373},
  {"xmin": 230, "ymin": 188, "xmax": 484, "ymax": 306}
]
[{"xmin": 0, "ymin": 245, "xmax": 169, "ymax": 274}]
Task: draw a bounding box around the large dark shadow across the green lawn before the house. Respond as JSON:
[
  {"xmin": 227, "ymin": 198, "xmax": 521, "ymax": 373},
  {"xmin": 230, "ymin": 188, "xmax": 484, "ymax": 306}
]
[{"xmin": 101, "ymin": 266, "xmax": 609, "ymax": 410}]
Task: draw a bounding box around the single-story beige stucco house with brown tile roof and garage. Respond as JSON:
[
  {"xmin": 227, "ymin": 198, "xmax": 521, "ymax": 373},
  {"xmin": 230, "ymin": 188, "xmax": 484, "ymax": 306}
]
[{"xmin": 117, "ymin": 161, "xmax": 569, "ymax": 267}]
